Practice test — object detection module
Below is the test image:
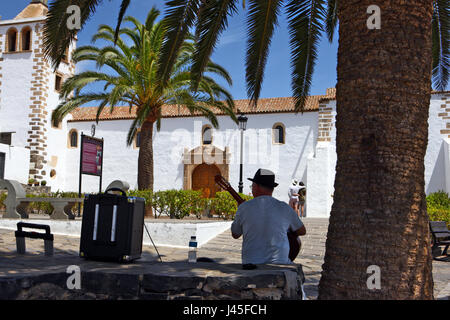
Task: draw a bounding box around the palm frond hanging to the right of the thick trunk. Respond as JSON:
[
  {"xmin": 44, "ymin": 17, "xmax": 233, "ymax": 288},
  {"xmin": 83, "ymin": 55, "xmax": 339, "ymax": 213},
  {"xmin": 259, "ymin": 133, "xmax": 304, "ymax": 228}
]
[{"xmin": 432, "ymin": 0, "xmax": 450, "ymax": 91}]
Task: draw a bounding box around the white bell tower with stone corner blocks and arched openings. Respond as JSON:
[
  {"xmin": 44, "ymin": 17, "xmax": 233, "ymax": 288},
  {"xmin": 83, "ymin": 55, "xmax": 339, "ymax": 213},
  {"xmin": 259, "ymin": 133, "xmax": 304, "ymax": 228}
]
[{"xmin": 0, "ymin": 0, "xmax": 76, "ymax": 182}]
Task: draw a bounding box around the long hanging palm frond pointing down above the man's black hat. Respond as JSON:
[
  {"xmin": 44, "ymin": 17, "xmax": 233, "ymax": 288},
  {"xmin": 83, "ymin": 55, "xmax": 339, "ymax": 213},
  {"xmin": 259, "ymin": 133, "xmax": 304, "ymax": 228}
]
[{"xmin": 246, "ymin": 0, "xmax": 282, "ymax": 106}]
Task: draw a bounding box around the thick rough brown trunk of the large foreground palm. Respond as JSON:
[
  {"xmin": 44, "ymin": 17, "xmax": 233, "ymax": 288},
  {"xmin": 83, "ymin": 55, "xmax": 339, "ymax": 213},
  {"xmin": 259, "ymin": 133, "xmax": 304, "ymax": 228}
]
[{"xmin": 319, "ymin": 0, "xmax": 433, "ymax": 299}]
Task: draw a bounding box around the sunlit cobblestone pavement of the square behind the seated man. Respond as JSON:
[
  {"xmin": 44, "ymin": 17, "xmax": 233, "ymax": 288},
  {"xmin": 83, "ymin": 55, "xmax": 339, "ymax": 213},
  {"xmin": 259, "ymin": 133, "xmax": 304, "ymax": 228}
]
[{"xmin": 0, "ymin": 218, "xmax": 450, "ymax": 299}]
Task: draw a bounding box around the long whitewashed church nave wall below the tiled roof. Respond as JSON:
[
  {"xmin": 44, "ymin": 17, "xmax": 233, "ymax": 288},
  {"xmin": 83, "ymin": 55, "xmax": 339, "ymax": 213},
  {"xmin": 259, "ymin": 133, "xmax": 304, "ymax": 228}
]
[{"xmin": 64, "ymin": 112, "xmax": 317, "ymax": 201}]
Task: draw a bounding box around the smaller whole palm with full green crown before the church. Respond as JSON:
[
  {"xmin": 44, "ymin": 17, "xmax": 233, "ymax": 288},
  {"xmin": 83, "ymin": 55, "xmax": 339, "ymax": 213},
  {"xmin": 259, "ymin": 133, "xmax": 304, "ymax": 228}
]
[{"xmin": 52, "ymin": 8, "xmax": 237, "ymax": 190}]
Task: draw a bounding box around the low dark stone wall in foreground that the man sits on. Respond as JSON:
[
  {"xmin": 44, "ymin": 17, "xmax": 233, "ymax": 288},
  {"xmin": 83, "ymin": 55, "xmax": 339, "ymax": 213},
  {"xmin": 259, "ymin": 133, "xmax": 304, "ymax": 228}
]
[{"xmin": 0, "ymin": 263, "xmax": 304, "ymax": 300}]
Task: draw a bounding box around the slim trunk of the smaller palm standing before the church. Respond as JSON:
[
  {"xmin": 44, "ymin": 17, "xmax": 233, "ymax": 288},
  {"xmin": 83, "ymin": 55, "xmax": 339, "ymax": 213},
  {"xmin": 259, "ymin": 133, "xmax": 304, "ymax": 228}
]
[{"xmin": 138, "ymin": 121, "xmax": 154, "ymax": 190}]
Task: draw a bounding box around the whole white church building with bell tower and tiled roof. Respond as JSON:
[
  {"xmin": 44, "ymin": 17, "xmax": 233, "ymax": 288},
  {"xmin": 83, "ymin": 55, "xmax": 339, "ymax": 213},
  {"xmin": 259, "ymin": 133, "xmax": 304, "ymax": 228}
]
[{"xmin": 0, "ymin": 0, "xmax": 450, "ymax": 217}]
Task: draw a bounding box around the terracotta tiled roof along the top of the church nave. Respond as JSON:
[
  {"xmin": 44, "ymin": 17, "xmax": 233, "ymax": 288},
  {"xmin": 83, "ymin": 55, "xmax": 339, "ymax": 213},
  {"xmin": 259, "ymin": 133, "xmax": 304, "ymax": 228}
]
[{"xmin": 69, "ymin": 90, "xmax": 333, "ymax": 122}]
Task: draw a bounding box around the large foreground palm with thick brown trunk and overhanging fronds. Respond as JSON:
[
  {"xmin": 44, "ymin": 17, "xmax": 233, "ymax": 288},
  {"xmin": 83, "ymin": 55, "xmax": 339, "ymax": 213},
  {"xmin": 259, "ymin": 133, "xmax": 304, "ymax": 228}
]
[{"xmin": 43, "ymin": 0, "xmax": 450, "ymax": 299}]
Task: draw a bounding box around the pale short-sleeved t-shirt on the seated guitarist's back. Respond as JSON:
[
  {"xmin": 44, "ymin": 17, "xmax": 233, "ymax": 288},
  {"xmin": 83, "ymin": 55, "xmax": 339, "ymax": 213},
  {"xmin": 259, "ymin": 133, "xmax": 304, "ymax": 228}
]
[{"xmin": 231, "ymin": 196, "xmax": 303, "ymax": 264}]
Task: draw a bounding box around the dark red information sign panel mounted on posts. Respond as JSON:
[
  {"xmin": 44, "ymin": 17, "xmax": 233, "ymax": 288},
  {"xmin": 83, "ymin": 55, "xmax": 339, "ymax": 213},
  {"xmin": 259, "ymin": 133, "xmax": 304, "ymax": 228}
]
[{"xmin": 81, "ymin": 136, "xmax": 103, "ymax": 176}]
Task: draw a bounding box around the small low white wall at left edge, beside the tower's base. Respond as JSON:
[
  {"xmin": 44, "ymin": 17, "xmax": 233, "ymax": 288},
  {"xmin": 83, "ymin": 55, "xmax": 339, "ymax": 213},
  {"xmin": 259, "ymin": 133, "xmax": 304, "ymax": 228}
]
[{"xmin": 0, "ymin": 144, "xmax": 30, "ymax": 184}]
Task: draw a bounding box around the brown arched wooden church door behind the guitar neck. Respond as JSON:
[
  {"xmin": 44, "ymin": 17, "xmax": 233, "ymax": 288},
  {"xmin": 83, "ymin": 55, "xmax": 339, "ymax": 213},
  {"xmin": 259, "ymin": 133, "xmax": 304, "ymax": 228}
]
[{"xmin": 192, "ymin": 163, "xmax": 221, "ymax": 198}]
